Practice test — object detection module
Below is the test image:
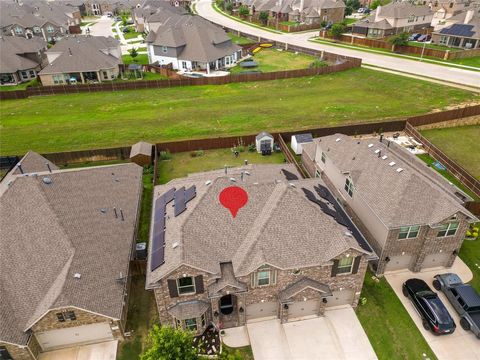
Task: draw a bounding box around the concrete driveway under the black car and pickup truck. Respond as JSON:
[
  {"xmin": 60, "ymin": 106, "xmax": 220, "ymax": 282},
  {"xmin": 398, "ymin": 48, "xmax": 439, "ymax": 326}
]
[{"xmin": 385, "ymin": 258, "xmax": 480, "ymax": 360}]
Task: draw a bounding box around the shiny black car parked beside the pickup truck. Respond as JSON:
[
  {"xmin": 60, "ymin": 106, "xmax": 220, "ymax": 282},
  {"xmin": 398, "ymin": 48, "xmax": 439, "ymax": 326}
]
[{"xmin": 402, "ymin": 279, "xmax": 456, "ymax": 335}]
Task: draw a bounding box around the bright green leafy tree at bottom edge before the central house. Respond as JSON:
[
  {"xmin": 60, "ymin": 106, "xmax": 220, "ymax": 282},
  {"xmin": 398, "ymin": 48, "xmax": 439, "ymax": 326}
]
[{"xmin": 140, "ymin": 325, "xmax": 199, "ymax": 360}]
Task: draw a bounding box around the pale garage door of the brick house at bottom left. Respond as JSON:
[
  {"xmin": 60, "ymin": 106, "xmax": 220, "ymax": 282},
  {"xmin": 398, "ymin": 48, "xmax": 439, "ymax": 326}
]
[{"xmin": 35, "ymin": 323, "xmax": 113, "ymax": 351}]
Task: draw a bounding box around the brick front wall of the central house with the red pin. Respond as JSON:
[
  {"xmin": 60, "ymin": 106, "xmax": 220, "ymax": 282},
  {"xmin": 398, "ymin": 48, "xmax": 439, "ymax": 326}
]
[{"xmin": 154, "ymin": 250, "xmax": 368, "ymax": 333}]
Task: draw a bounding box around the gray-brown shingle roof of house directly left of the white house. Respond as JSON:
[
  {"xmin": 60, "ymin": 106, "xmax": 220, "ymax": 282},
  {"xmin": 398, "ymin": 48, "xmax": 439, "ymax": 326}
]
[{"xmin": 39, "ymin": 36, "xmax": 122, "ymax": 75}]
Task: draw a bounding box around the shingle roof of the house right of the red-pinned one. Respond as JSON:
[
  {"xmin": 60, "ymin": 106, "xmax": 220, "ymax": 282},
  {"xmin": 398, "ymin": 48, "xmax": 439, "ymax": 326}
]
[{"xmin": 314, "ymin": 134, "xmax": 475, "ymax": 228}]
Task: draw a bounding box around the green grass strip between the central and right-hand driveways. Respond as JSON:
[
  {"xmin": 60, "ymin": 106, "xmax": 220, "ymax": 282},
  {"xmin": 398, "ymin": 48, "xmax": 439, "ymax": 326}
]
[{"xmin": 356, "ymin": 271, "xmax": 436, "ymax": 360}]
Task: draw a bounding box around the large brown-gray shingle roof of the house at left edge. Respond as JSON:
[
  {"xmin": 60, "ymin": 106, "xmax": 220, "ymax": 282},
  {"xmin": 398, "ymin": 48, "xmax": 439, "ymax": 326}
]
[{"xmin": 0, "ymin": 164, "xmax": 142, "ymax": 345}]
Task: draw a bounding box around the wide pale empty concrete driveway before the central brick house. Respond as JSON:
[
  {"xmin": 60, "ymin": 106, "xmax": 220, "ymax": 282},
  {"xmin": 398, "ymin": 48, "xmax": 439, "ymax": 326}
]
[{"xmin": 247, "ymin": 307, "xmax": 377, "ymax": 360}]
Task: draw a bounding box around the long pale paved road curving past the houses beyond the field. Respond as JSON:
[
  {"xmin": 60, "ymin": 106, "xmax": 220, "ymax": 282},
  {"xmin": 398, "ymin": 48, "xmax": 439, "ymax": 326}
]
[{"xmin": 196, "ymin": 0, "xmax": 480, "ymax": 89}]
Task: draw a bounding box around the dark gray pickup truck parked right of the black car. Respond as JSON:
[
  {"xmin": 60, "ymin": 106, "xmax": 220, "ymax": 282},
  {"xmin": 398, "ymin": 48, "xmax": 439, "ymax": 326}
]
[{"xmin": 433, "ymin": 273, "xmax": 480, "ymax": 339}]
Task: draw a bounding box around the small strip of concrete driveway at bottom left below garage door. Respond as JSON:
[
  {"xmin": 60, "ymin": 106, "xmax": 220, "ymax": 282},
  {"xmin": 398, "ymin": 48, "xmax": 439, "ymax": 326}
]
[{"xmin": 38, "ymin": 340, "xmax": 118, "ymax": 360}]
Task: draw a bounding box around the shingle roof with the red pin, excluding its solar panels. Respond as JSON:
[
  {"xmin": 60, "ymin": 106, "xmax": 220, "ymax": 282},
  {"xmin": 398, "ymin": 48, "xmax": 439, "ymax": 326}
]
[{"xmin": 147, "ymin": 165, "xmax": 369, "ymax": 286}]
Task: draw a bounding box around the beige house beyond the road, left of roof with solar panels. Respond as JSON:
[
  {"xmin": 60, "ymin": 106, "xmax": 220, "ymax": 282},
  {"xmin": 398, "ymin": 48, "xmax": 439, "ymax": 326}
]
[{"xmin": 352, "ymin": 1, "xmax": 433, "ymax": 38}]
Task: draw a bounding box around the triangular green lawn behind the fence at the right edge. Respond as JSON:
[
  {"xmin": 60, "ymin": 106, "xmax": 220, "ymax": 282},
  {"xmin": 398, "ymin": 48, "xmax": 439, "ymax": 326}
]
[{"xmin": 422, "ymin": 125, "xmax": 480, "ymax": 179}]
